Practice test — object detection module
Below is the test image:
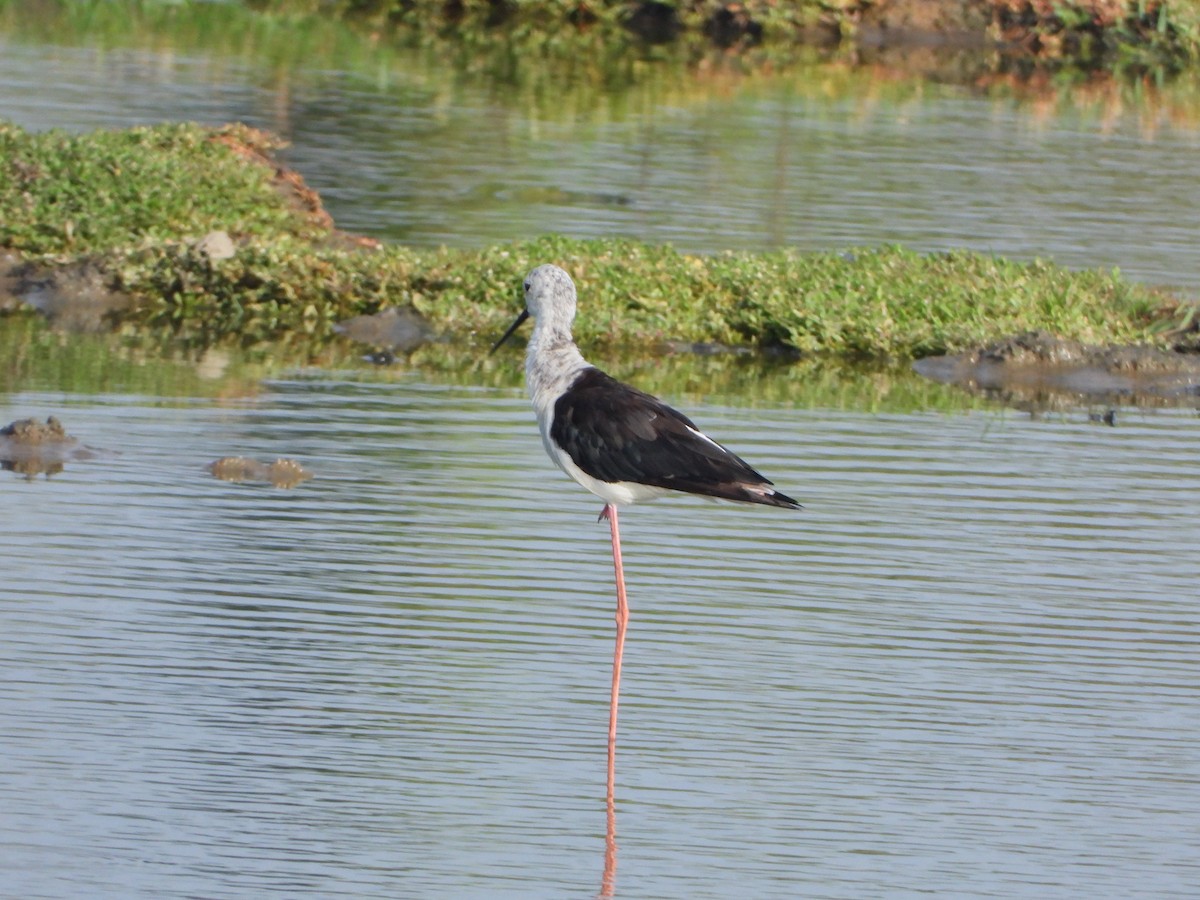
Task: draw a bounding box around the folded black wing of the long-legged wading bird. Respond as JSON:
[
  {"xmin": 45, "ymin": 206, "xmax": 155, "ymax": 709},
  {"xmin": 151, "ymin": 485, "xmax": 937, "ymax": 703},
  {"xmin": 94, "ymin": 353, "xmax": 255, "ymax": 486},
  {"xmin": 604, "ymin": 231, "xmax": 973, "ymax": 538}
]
[{"xmin": 550, "ymin": 367, "xmax": 798, "ymax": 506}]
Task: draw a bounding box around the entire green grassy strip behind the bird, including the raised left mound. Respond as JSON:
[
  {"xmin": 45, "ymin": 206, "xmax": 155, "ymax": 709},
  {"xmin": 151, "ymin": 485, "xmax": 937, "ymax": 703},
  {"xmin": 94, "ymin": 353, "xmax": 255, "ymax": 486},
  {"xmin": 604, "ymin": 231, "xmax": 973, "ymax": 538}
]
[{"xmin": 0, "ymin": 125, "xmax": 1178, "ymax": 360}]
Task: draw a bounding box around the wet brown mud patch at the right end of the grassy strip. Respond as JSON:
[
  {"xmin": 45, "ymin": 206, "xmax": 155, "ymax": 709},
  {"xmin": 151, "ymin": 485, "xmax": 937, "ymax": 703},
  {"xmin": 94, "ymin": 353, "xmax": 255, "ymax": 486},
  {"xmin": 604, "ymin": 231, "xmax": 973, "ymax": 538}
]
[{"xmin": 913, "ymin": 331, "xmax": 1200, "ymax": 412}]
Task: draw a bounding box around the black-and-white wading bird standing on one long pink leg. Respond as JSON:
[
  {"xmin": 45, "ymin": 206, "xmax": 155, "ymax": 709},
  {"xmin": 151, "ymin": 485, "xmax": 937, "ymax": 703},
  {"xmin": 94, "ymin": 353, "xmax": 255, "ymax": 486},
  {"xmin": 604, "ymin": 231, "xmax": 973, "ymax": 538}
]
[{"xmin": 491, "ymin": 264, "xmax": 800, "ymax": 815}]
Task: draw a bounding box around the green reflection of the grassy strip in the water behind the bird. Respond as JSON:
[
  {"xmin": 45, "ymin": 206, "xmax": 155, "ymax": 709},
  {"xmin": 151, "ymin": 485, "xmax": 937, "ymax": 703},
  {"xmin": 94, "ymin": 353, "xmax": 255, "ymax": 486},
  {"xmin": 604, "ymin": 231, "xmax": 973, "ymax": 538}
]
[{"xmin": 0, "ymin": 307, "xmax": 986, "ymax": 413}]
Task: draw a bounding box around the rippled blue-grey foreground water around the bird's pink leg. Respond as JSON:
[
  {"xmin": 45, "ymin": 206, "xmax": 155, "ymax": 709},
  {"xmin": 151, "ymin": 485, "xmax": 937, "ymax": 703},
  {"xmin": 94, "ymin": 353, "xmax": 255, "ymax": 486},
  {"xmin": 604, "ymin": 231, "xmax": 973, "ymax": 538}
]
[{"xmin": 0, "ymin": 378, "xmax": 1200, "ymax": 898}]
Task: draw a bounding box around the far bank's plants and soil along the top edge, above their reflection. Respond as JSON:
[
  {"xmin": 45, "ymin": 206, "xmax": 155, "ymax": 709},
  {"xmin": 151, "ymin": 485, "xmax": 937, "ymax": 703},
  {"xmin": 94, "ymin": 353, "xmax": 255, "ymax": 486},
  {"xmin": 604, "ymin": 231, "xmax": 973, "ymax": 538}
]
[{"xmin": 258, "ymin": 0, "xmax": 1200, "ymax": 67}]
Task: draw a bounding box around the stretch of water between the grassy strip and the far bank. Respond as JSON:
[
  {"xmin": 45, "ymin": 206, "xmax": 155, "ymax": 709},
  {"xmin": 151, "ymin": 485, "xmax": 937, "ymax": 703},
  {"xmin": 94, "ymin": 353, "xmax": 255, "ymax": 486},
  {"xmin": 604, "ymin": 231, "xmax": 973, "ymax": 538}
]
[{"xmin": 0, "ymin": 30, "xmax": 1200, "ymax": 294}]
